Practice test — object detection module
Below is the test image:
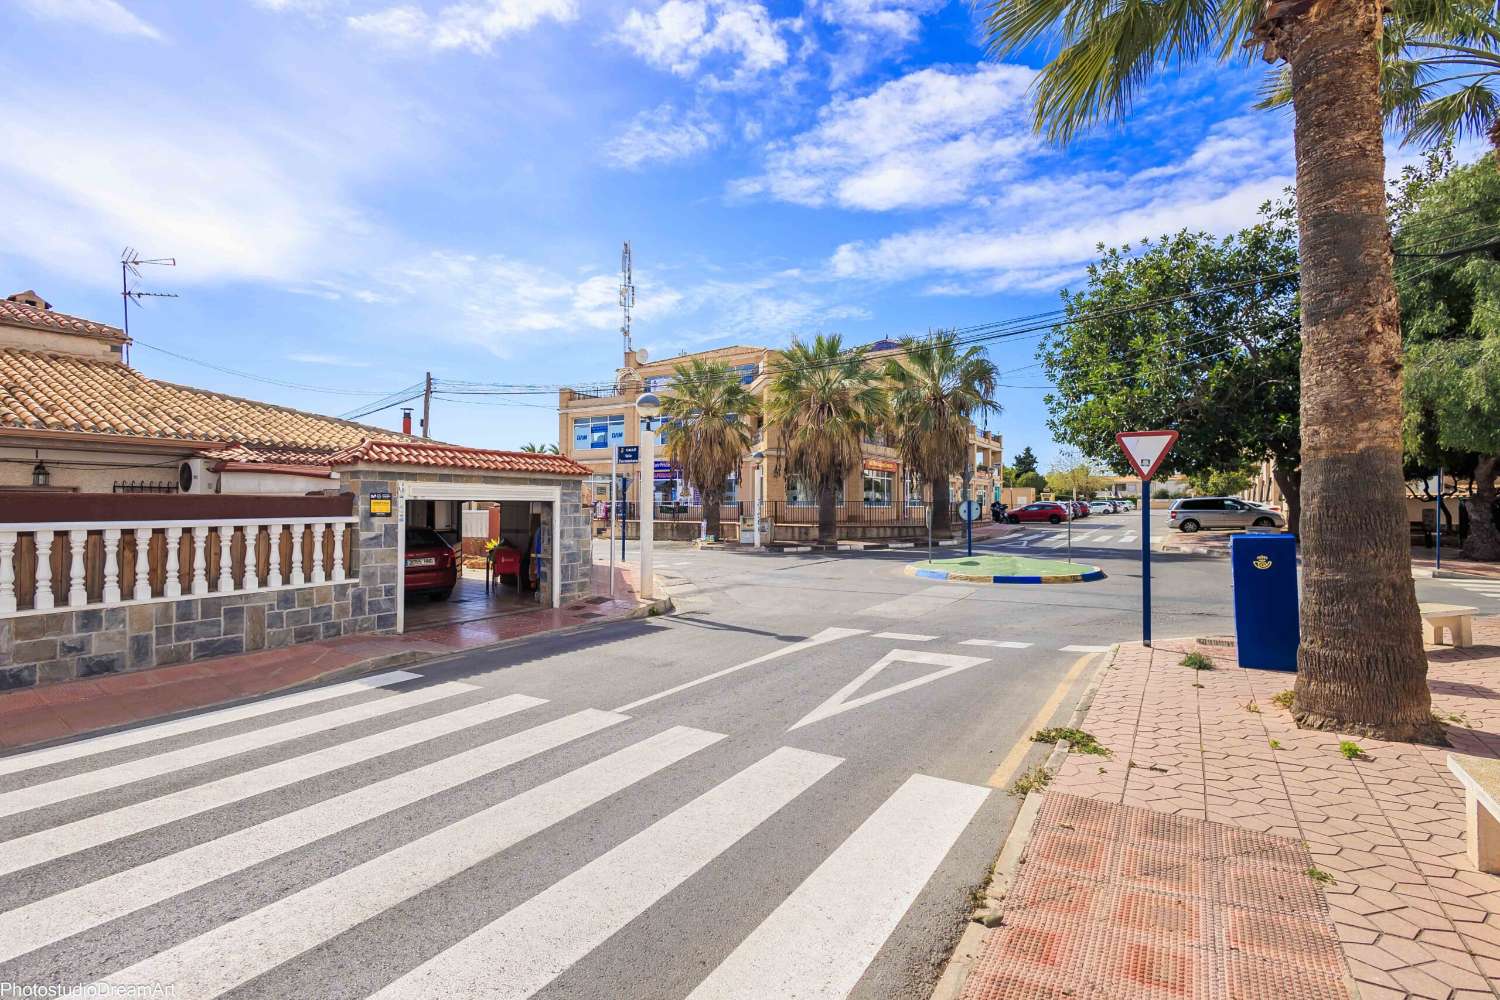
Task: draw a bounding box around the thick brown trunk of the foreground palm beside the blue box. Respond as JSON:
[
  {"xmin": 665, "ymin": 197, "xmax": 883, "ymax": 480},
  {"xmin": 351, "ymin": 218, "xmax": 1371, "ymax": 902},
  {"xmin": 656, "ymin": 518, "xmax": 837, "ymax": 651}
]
[{"xmin": 1280, "ymin": 0, "xmax": 1443, "ymax": 742}]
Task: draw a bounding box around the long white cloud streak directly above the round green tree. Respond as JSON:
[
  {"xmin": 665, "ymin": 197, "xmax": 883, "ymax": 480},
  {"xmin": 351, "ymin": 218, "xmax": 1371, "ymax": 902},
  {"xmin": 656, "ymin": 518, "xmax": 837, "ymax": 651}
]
[{"xmin": 830, "ymin": 114, "xmax": 1293, "ymax": 294}]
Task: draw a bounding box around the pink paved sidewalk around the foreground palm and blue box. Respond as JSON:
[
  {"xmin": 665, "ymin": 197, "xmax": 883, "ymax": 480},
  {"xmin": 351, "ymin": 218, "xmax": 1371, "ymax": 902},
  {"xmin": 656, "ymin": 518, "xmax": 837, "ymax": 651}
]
[{"xmin": 956, "ymin": 618, "xmax": 1500, "ymax": 1000}]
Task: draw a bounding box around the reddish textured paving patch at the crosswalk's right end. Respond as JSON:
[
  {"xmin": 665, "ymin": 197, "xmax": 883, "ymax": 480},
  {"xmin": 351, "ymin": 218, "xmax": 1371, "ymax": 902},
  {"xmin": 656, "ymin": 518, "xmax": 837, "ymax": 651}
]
[{"xmin": 963, "ymin": 792, "xmax": 1349, "ymax": 1000}]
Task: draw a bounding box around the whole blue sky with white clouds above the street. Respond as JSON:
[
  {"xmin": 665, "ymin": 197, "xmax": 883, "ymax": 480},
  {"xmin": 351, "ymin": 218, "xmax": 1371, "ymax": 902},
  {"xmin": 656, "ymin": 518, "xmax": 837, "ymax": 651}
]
[{"xmin": 0, "ymin": 0, "xmax": 1320, "ymax": 463}]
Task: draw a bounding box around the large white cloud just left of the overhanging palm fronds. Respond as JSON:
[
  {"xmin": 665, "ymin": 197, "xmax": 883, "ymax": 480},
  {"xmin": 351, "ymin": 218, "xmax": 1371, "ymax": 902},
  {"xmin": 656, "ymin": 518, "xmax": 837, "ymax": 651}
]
[{"xmin": 732, "ymin": 63, "xmax": 1037, "ymax": 211}]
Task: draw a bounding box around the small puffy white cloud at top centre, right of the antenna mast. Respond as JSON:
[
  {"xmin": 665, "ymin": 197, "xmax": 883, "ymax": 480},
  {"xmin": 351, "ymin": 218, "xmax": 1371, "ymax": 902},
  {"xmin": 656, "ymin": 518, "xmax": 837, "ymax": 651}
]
[{"xmin": 620, "ymin": 0, "xmax": 798, "ymax": 87}]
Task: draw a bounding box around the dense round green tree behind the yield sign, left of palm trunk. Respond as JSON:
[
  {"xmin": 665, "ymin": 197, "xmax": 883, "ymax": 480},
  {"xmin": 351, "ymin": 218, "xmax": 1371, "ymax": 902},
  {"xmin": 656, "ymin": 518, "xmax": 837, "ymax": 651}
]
[{"xmin": 1040, "ymin": 211, "xmax": 1302, "ymax": 531}]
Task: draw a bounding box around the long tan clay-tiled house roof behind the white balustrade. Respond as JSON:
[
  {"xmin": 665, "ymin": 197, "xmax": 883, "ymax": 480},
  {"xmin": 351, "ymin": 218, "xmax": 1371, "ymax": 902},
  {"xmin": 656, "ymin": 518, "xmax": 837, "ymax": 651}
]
[{"xmin": 0, "ymin": 348, "xmax": 411, "ymax": 452}]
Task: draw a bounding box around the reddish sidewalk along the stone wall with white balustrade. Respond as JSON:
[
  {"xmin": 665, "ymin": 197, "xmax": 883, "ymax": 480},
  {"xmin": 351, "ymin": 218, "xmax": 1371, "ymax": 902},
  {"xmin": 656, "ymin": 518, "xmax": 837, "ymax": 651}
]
[{"xmin": 0, "ymin": 565, "xmax": 653, "ymax": 750}]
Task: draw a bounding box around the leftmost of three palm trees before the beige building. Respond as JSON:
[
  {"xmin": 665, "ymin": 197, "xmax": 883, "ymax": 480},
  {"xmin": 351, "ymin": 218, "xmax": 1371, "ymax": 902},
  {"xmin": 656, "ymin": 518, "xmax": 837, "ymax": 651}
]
[{"xmin": 662, "ymin": 360, "xmax": 759, "ymax": 538}]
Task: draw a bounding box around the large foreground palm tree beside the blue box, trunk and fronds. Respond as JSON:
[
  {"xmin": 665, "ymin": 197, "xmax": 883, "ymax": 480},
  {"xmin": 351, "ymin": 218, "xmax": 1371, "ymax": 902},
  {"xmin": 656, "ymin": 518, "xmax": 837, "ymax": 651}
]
[{"xmin": 986, "ymin": 0, "xmax": 1463, "ymax": 742}]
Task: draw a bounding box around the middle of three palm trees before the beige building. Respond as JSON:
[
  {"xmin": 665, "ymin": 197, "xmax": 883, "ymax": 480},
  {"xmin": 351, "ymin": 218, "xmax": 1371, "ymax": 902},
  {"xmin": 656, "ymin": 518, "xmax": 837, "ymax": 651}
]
[{"xmin": 765, "ymin": 334, "xmax": 885, "ymax": 544}]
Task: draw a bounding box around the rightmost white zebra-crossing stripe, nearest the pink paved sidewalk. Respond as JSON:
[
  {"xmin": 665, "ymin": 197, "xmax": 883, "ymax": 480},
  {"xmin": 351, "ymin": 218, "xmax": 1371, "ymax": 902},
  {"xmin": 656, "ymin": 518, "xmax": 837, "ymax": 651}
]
[{"xmin": 689, "ymin": 775, "xmax": 989, "ymax": 1000}]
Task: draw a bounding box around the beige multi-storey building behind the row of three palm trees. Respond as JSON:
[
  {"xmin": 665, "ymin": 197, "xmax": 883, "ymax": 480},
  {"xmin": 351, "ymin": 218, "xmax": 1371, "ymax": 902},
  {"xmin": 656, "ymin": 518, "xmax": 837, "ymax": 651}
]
[{"xmin": 558, "ymin": 340, "xmax": 1004, "ymax": 534}]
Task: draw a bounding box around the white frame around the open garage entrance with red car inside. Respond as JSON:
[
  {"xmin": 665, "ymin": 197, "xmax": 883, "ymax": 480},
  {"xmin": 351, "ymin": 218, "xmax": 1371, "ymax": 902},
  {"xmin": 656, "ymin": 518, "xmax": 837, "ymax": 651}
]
[{"xmin": 396, "ymin": 480, "xmax": 563, "ymax": 631}]
